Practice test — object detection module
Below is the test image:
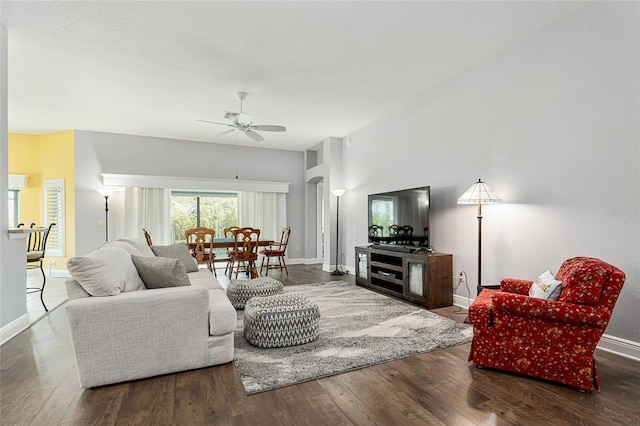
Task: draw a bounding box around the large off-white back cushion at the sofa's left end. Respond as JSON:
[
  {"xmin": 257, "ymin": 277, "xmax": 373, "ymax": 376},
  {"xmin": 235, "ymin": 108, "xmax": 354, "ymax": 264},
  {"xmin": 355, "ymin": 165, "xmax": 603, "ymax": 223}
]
[{"xmin": 67, "ymin": 244, "xmax": 145, "ymax": 296}]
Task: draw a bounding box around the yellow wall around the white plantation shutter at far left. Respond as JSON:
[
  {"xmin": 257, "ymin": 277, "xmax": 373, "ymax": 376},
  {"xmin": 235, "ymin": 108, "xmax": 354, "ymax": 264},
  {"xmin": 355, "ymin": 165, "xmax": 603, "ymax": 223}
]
[{"xmin": 8, "ymin": 130, "xmax": 76, "ymax": 269}]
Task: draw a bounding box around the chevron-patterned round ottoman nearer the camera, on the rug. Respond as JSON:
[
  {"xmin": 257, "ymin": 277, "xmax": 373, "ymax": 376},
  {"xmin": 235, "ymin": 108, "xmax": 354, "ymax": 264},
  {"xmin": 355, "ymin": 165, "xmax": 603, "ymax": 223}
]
[{"xmin": 244, "ymin": 293, "xmax": 320, "ymax": 348}]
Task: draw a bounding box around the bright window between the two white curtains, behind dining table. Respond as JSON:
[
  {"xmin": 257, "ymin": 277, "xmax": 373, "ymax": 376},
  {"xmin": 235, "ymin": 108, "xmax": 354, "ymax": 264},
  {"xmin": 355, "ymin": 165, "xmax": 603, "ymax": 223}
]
[{"xmin": 169, "ymin": 191, "xmax": 238, "ymax": 242}]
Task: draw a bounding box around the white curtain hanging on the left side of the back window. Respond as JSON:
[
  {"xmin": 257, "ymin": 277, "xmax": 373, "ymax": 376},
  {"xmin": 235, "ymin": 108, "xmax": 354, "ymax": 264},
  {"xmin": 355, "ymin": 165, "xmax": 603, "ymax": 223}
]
[{"xmin": 124, "ymin": 188, "xmax": 171, "ymax": 245}]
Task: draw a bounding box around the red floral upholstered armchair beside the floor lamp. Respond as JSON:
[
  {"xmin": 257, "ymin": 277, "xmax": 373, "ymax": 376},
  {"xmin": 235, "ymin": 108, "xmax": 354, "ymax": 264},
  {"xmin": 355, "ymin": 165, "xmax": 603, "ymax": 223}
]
[{"xmin": 469, "ymin": 257, "xmax": 625, "ymax": 392}]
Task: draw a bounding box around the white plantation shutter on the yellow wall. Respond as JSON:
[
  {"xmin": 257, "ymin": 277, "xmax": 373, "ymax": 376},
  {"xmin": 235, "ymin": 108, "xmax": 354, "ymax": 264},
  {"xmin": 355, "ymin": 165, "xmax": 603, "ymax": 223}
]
[{"xmin": 44, "ymin": 179, "xmax": 65, "ymax": 257}]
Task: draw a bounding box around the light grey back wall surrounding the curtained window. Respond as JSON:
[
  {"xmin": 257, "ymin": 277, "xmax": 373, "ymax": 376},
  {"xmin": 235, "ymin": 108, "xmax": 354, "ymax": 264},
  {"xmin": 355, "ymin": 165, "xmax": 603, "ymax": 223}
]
[{"xmin": 75, "ymin": 131, "xmax": 314, "ymax": 259}]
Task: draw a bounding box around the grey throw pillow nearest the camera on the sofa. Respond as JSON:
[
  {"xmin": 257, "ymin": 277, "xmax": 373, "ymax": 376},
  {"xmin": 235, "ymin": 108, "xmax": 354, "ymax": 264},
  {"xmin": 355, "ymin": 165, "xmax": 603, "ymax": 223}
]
[{"xmin": 131, "ymin": 254, "xmax": 191, "ymax": 289}]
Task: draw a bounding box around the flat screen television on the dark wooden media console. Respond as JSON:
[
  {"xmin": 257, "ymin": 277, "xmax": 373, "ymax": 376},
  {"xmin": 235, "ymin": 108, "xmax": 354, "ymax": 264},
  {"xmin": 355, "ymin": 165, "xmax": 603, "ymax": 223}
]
[{"xmin": 368, "ymin": 186, "xmax": 430, "ymax": 248}]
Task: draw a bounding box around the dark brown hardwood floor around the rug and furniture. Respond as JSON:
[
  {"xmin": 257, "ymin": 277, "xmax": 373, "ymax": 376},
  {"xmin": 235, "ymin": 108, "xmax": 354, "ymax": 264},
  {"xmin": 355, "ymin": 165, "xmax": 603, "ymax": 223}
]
[{"xmin": 0, "ymin": 265, "xmax": 640, "ymax": 426}]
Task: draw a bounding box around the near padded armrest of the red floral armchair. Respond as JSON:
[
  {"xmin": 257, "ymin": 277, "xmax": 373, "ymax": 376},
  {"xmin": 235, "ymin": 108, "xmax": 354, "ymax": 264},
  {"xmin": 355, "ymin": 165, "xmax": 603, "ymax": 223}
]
[{"xmin": 492, "ymin": 292, "xmax": 611, "ymax": 328}]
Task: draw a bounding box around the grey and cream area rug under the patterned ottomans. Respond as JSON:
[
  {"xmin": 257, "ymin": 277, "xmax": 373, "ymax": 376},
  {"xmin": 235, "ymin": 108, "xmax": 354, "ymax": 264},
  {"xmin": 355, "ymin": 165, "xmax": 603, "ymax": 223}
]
[{"xmin": 234, "ymin": 281, "xmax": 473, "ymax": 395}]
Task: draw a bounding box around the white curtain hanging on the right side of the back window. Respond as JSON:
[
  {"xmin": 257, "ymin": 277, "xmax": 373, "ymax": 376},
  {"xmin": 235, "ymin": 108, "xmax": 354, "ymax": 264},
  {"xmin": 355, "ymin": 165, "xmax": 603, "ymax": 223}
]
[{"xmin": 238, "ymin": 192, "xmax": 287, "ymax": 241}]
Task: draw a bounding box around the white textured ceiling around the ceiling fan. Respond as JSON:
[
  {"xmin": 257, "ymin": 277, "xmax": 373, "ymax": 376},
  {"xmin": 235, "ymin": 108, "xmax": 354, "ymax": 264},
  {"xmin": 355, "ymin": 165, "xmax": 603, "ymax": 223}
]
[{"xmin": 0, "ymin": 0, "xmax": 587, "ymax": 150}]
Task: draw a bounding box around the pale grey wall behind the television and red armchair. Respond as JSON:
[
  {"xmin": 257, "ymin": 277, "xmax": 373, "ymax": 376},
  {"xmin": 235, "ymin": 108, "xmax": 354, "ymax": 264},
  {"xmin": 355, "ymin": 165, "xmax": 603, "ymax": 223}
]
[{"xmin": 341, "ymin": 2, "xmax": 640, "ymax": 342}]
